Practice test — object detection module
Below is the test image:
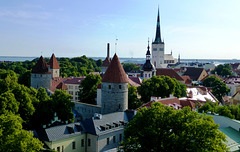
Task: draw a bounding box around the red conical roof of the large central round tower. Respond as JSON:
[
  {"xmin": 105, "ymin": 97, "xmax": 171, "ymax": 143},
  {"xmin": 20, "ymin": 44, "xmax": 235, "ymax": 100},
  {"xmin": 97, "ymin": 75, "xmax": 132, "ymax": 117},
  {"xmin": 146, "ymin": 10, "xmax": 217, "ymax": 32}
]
[{"xmin": 102, "ymin": 53, "xmax": 128, "ymax": 83}]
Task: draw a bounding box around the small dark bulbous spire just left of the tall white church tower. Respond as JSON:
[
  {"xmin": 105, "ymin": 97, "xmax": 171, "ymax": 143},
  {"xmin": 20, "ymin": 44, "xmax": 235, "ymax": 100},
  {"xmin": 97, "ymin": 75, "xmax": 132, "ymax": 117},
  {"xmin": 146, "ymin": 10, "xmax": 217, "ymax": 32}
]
[{"xmin": 141, "ymin": 40, "xmax": 156, "ymax": 79}]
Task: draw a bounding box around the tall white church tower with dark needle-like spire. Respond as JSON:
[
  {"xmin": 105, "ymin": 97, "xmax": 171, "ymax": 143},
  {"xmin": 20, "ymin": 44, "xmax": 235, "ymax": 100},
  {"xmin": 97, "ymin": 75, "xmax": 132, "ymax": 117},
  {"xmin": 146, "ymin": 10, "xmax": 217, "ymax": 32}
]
[{"xmin": 152, "ymin": 9, "xmax": 164, "ymax": 68}]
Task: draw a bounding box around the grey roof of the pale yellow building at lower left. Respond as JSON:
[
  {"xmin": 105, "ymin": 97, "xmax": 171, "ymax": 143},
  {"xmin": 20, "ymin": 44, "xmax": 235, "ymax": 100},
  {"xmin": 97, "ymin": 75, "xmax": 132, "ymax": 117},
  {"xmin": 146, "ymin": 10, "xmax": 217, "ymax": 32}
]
[{"xmin": 36, "ymin": 122, "xmax": 85, "ymax": 142}]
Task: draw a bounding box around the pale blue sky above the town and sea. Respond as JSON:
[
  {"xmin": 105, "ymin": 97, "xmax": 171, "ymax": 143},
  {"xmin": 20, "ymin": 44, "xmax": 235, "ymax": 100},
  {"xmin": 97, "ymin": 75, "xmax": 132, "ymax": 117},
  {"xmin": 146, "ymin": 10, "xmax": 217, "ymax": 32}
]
[{"xmin": 0, "ymin": 0, "xmax": 240, "ymax": 59}]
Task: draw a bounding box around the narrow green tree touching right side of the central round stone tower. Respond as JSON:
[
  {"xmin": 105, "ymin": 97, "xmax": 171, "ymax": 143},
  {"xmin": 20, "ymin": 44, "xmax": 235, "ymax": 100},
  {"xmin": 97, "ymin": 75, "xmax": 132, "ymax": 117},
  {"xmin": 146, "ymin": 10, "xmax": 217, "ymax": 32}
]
[{"xmin": 128, "ymin": 85, "xmax": 142, "ymax": 109}]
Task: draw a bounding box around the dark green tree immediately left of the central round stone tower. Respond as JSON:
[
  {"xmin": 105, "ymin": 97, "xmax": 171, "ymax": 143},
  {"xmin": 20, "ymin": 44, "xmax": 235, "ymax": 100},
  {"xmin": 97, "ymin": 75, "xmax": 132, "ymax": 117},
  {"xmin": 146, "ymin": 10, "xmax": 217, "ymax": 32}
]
[{"xmin": 79, "ymin": 74, "xmax": 102, "ymax": 104}]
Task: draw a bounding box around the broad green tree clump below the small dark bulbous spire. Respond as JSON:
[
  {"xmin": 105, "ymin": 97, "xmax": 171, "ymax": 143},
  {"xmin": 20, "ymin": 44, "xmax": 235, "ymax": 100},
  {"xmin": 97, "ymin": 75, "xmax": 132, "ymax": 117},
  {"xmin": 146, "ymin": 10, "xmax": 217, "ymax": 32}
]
[{"xmin": 138, "ymin": 75, "xmax": 186, "ymax": 103}]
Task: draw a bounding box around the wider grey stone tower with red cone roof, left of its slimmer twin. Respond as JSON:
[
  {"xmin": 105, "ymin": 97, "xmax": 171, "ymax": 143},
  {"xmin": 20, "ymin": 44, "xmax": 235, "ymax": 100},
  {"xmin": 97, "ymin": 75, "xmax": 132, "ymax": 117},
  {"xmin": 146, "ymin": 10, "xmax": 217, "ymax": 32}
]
[{"xmin": 31, "ymin": 56, "xmax": 52, "ymax": 89}]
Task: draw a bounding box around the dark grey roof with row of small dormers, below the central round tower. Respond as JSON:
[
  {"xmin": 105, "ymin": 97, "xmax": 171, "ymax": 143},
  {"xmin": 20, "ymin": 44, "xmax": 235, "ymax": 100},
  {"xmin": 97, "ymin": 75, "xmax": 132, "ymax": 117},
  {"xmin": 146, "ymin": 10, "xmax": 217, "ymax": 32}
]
[{"xmin": 83, "ymin": 112, "xmax": 130, "ymax": 135}]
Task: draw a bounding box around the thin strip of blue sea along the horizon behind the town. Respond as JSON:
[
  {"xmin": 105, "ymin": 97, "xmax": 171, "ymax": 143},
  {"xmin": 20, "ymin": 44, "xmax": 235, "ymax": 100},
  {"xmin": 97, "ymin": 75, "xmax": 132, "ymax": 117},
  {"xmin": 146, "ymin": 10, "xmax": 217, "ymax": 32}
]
[{"xmin": 0, "ymin": 56, "xmax": 240, "ymax": 65}]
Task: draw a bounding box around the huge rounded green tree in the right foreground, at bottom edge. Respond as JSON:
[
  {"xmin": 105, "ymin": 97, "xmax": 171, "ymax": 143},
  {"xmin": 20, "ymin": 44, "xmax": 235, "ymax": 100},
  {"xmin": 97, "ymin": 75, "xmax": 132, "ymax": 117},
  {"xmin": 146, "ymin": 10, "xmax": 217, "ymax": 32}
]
[{"xmin": 122, "ymin": 103, "xmax": 226, "ymax": 152}]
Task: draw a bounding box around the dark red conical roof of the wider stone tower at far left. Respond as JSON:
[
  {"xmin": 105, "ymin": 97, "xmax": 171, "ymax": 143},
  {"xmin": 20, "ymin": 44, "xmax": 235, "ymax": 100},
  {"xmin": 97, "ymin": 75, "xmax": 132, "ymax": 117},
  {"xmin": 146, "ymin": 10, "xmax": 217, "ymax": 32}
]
[{"xmin": 32, "ymin": 56, "xmax": 51, "ymax": 74}]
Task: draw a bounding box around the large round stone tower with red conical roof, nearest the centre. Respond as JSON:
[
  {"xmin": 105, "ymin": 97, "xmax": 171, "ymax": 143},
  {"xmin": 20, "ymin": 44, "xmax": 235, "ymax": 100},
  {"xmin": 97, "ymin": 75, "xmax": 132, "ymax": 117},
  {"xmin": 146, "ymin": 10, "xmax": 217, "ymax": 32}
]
[{"xmin": 101, "ymin": 54, "xmax": 128, "ymax": 114}]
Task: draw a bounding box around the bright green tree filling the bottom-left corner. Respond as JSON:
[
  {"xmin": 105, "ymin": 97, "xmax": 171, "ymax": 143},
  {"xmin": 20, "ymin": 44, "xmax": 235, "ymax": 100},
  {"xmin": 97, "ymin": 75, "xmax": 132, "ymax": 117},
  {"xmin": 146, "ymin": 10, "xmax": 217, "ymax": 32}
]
[{"xmin": 0, "ymin": 114, "xmax": 43, "ymax": 152}]
